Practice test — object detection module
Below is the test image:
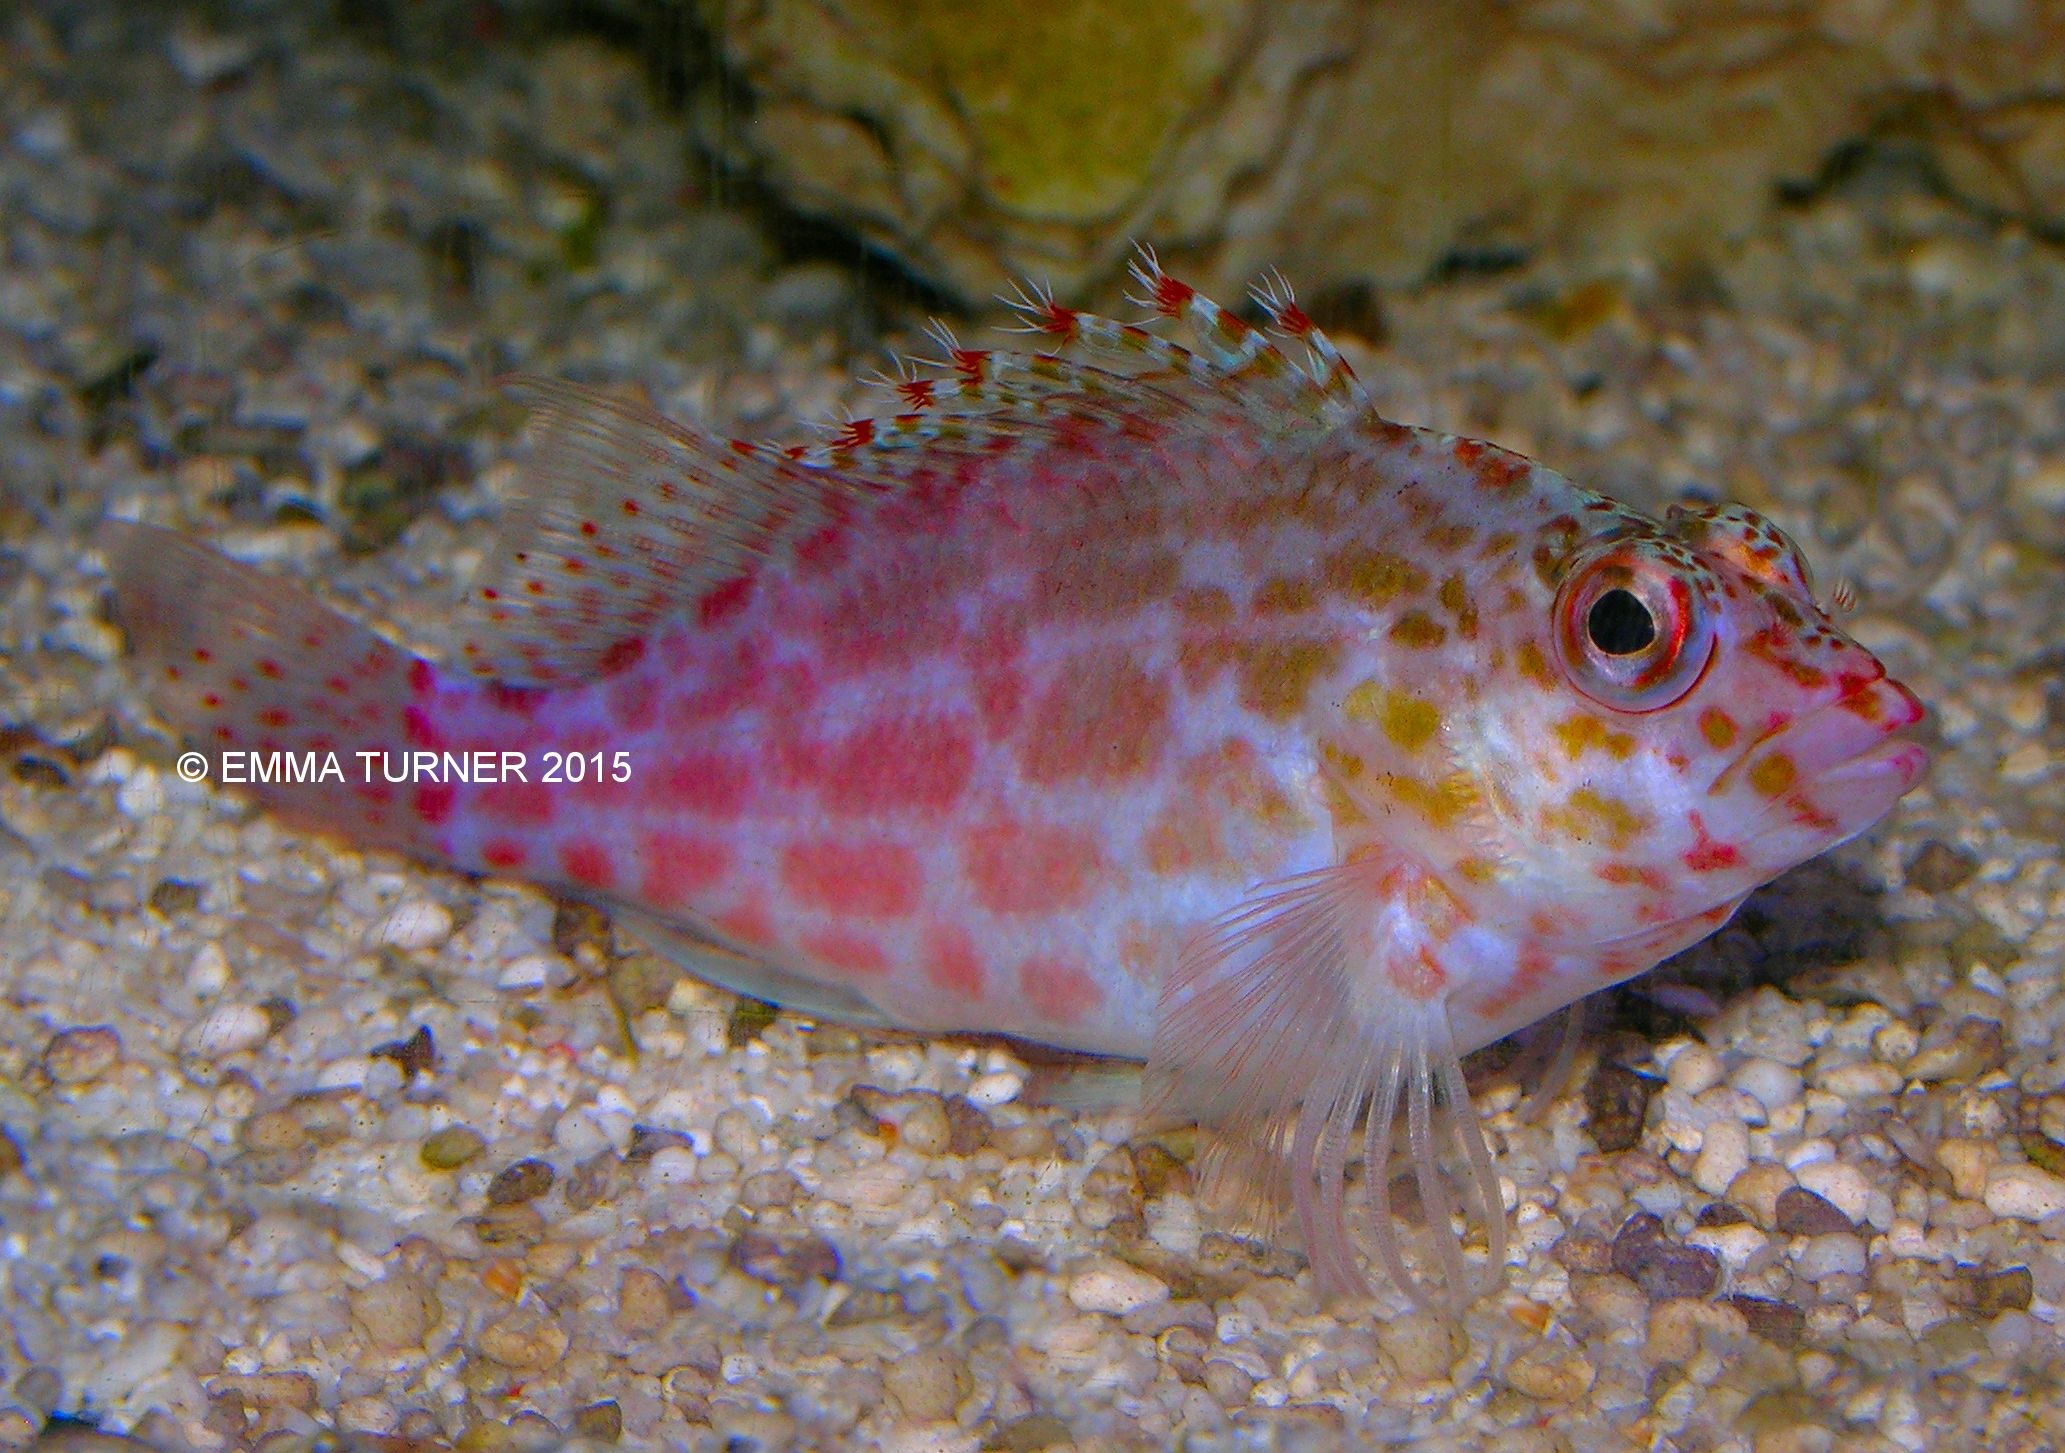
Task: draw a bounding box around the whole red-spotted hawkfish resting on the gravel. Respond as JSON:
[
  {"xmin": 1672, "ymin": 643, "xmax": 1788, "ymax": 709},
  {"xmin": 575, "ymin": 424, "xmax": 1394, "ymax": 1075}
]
[{"xmin": 103, "ymin": 260, "xmax": 1925, "ymax": 1298}]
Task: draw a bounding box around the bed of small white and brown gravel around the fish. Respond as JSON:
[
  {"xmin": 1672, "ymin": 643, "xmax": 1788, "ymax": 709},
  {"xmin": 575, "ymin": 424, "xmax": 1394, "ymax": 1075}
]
[{"xmin": 0, "ymin": 4, "xmax": 2065, "ymax": 1453}]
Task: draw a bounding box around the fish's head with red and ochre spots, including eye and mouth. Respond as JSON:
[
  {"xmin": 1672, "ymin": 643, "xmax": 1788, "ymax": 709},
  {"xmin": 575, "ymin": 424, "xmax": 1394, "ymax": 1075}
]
[{"xmin": 1499, "ymin": 506, "xmax": 1927, "ymax": 953}]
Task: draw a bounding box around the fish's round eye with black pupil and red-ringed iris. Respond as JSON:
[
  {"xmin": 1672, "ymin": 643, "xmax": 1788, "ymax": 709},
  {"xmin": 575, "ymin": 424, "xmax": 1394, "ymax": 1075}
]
[{"xmin": 1555, "ymin": 539, "xmax": 1714, "ymax": 712}]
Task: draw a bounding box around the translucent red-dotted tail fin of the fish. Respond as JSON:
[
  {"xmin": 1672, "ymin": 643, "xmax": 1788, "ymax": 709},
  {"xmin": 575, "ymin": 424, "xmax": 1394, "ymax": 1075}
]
[{"xmin": 95, "ymin": 520, "xmax": 434, "ymax": 852}]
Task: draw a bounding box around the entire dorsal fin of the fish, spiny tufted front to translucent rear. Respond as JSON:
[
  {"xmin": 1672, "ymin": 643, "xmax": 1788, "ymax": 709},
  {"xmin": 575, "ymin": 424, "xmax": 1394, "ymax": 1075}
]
[{"xmin": 460, "ymin": 250, "xmax": 1367, "ymax": 685}]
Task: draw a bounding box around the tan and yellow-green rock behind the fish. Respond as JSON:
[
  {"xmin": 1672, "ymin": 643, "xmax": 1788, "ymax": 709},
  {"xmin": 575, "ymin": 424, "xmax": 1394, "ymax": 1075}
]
[{"xmin": 696, "ymin": 0, "xmax": 2065, "ymax": 299}]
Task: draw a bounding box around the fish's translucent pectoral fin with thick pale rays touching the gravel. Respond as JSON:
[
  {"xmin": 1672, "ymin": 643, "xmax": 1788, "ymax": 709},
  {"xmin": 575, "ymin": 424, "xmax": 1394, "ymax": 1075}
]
[{"xmin": 1146, "ymin": 861, "xmax": 1505, "ymax": 1311}]
